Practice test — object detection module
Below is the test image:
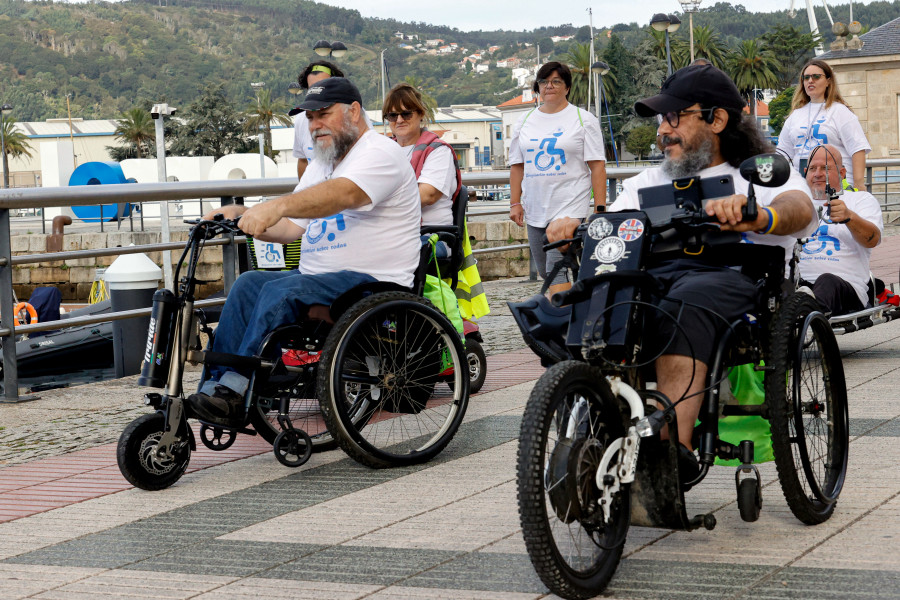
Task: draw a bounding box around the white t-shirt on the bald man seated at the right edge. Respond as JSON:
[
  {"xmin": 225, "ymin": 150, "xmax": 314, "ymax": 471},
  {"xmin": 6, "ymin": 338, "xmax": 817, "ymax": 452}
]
[{"xmin": 800, "ymin": 191, "xmax": 884, "ymax": 306}]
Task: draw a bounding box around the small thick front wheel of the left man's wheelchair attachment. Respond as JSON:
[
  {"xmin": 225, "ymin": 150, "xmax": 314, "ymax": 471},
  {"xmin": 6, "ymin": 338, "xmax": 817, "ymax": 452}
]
[{"xmin": 116, "ymin": 412, "xmax": 191, "ymax": 491}]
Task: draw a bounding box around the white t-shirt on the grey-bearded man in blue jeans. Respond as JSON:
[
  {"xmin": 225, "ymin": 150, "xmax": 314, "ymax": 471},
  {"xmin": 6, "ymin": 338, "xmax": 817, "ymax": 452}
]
[{"xmin": 291, "ymin": 129, "xmax": 422, "ymax": 286}]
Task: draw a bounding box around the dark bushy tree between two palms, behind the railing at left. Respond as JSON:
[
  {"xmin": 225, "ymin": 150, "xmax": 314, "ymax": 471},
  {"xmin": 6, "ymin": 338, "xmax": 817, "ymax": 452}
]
[{"xmin": 169, "ymin": 83, "xmax": 252, "ymax": 159}]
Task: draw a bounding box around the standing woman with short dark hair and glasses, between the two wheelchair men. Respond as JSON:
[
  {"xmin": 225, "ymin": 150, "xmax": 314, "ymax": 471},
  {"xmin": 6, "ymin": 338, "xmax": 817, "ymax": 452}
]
[{"xmin": 509, "ymin": 62, "xmax": 606, "ymax": 293}]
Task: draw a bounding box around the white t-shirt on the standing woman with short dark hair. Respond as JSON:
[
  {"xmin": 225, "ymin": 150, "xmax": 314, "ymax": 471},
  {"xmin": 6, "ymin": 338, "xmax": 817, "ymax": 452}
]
[{"xmin": 509, "ymin": 104, "xmax": 606, "ymax": 227}]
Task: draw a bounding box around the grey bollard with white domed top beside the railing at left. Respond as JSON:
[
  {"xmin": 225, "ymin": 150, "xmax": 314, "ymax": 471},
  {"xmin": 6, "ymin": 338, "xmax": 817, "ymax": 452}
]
[{"xmin": 103, "ymin": 254, "xmax": 162, "ymax": 377}]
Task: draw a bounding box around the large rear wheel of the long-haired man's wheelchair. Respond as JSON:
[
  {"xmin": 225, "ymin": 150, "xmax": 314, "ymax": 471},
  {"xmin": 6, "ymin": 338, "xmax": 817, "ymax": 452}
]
[{"xmin": 765, "ymin": 293, "xmax": 850, "ymax": 525}]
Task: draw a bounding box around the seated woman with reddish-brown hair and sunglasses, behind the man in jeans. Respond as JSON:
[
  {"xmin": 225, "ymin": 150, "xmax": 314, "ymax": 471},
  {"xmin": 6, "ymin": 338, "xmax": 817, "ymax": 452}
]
[{"xmin": 381, "ymin": 83, "xmax": 462, "ymax": 234}]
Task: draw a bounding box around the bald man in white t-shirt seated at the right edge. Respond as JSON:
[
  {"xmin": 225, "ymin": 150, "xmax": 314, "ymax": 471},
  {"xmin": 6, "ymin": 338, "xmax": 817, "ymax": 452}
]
[{"xmin": 800, "ymin": 145, "xmax": 884, "ymax": 315}]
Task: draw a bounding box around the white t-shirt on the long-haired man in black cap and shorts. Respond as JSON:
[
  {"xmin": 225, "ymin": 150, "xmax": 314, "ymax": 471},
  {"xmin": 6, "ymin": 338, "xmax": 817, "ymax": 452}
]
[{"xmin": 609, "ymin": 163, "xmax": 816, "ymax": 263}]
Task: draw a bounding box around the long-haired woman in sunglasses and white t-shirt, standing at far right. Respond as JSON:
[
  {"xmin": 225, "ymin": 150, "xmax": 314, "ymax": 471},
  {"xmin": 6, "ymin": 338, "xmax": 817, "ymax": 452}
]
[{"xmin": 778, "ymin": 59, "xmax": 872, "ymax": 190}]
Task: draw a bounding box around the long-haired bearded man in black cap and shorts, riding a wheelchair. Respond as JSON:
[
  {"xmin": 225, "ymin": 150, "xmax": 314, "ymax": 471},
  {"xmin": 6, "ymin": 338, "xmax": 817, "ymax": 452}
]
[{"xmin": 547, "ymin": 65, "xmax": 816, "ymax": 481}]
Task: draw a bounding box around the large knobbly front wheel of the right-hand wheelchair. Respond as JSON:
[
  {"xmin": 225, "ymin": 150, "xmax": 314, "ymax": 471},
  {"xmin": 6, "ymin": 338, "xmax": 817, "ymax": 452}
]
[{"xmin": 518, "ymin": 361, "xmax": 631, "ymax": 598}]
